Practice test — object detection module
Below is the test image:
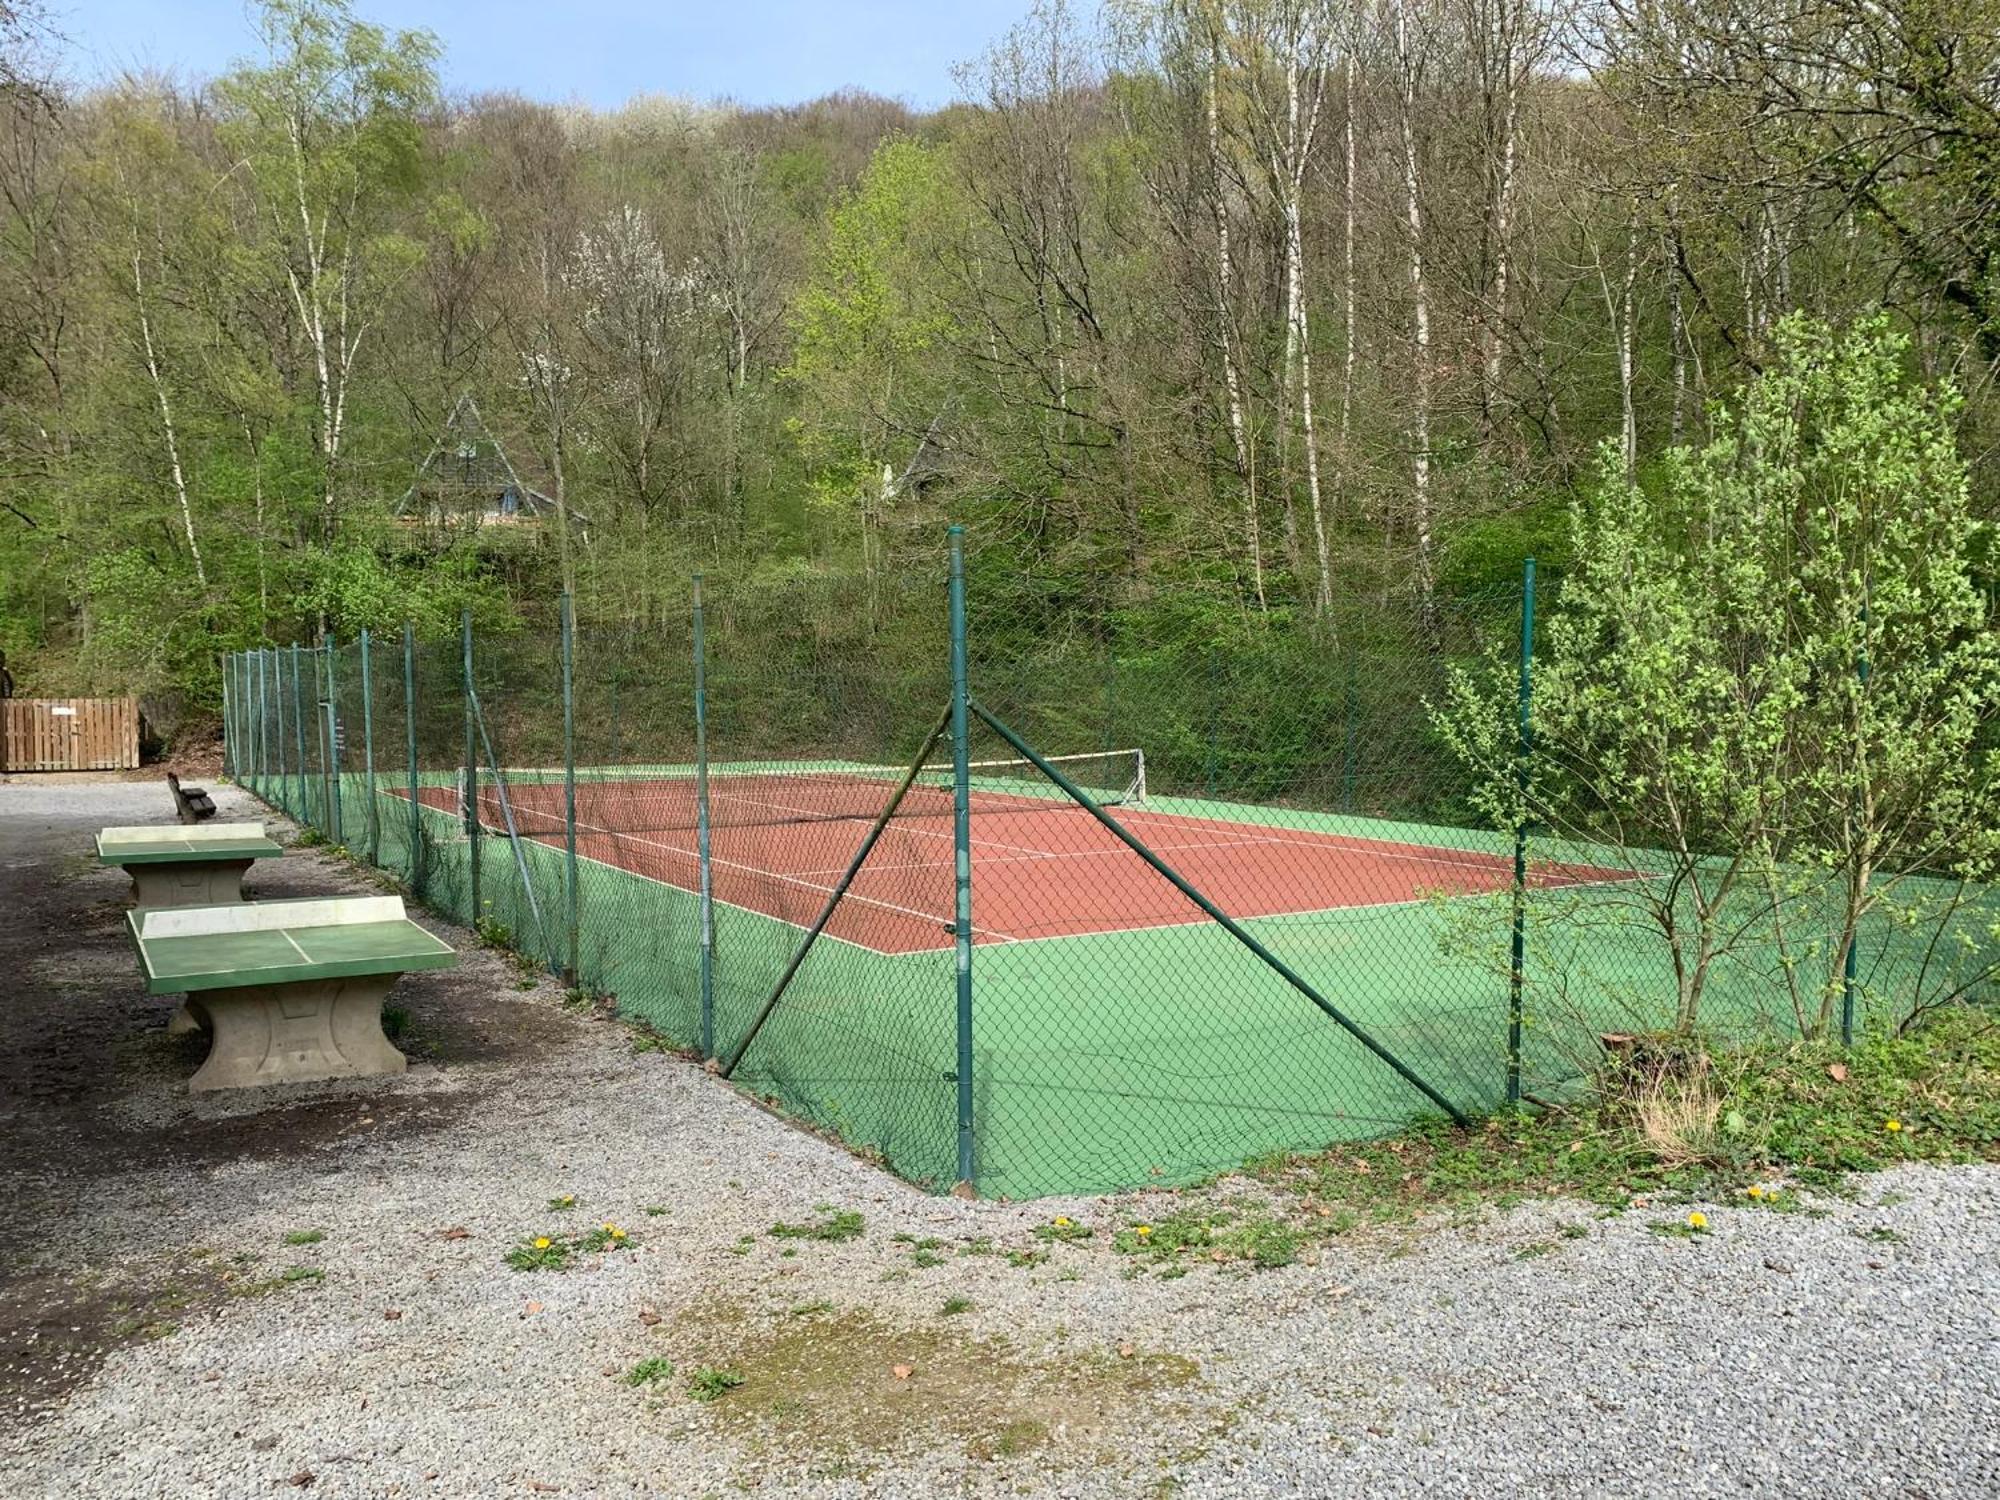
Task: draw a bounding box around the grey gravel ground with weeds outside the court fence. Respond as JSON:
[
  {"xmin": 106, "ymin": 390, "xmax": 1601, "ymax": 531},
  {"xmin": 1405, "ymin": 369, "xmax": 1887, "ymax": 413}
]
[{"xmin": 0, "ymin": 784, "xmax": 2000, "ymax": 1500}]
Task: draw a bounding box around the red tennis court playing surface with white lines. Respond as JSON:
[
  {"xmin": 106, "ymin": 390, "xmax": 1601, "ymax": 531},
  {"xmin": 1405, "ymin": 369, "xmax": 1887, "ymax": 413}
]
[{"xmin": 406, "ymin": 782, "xmax": 1622, "ymax": 954}]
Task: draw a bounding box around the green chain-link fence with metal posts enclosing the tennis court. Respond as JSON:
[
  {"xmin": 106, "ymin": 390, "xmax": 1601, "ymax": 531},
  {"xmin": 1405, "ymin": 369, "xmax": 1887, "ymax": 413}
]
[{"xmin": 228, "ymin": 536, "xmax": 1994, "ymax": 1196}]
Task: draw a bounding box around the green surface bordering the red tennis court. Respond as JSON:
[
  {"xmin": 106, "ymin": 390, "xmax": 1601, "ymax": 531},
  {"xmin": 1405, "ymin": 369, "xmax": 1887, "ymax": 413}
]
[{"xmin": 242, "ymin": 768, "xmax": 1996, "ymax": 1198}]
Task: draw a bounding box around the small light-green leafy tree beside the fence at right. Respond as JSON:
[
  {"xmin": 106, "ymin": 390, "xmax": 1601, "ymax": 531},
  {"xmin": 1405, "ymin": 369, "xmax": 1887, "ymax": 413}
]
[{"xmin": 1436, "ymin": 316, "xmax": 2000, "ymax": 1034}]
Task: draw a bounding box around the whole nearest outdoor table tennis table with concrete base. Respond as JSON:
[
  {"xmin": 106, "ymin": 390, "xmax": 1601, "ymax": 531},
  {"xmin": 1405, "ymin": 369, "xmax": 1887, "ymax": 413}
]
[{"xmin": 126, "ymin": 896, "xmax": 458, "ymax": 1092}]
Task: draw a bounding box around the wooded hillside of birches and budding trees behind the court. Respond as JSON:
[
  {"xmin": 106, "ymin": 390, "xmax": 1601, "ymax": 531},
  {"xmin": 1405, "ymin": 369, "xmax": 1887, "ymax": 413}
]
[{"xmin": 0, "ymin": 0, "xmax": 2000, "ymax": 730}]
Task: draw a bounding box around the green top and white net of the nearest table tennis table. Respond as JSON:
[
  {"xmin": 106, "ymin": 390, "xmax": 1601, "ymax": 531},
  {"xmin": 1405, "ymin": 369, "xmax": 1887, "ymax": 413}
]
[{"xmin": 126, "ymin": 896, "xmax": 458, "ymax": 994}]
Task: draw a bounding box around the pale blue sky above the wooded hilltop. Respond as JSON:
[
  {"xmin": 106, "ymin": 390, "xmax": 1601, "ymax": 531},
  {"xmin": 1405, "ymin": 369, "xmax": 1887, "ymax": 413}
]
[{"xmin": 50, "ymin": 0, "xmax": 1028, "ymax": 106}]
